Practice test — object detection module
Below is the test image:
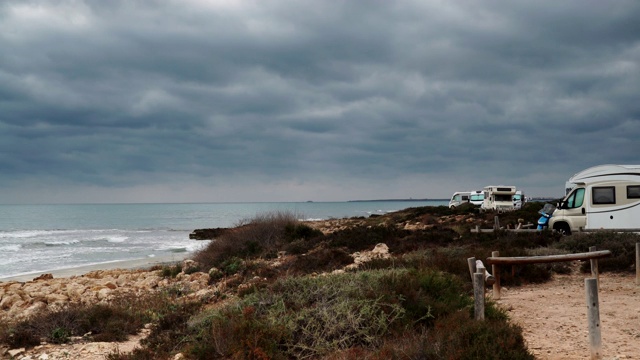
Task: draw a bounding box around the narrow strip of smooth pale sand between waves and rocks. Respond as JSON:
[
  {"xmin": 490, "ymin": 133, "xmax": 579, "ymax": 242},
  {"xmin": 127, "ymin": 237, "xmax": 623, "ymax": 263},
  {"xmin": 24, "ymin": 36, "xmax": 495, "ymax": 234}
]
[{"xmin": 0, "ymin": 252, "xmax": 192, "ymax": 283}]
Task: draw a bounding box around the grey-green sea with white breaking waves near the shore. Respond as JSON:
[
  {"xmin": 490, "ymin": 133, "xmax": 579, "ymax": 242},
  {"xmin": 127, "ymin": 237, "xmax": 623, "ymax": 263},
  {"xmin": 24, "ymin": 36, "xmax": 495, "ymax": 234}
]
[{"xmin": 0, "ymin": 200, "xmax": 448, "ymax": 279}]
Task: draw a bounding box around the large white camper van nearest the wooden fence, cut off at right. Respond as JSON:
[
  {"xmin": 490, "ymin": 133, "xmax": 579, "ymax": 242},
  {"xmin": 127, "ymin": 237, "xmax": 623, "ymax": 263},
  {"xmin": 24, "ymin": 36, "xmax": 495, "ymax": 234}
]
[{"xmin": 549, "ymin": 165, "xmax": 640, "ymax": 234}]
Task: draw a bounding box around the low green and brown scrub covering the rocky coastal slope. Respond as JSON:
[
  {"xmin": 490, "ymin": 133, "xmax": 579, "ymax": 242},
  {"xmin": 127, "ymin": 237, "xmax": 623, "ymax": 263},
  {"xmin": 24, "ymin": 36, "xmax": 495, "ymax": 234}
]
[{"xmin": 0, "ymin": 203, "xmax": 639, "ymax": 360}]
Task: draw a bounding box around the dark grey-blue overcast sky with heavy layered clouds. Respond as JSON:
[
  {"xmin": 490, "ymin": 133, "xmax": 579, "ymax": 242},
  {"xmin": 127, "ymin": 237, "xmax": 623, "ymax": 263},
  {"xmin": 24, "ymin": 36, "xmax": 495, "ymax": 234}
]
[{"xmin": 0, "ymin": 0, "xmax": 640, "ymax": 204}]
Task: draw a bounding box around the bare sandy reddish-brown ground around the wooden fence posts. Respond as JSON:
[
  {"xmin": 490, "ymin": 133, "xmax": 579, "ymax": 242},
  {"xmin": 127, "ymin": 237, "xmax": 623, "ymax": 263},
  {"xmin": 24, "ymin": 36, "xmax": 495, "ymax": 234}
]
[{"xmin": 497, "ymin": 273, "xmax": 640, "ymax": 360}]
